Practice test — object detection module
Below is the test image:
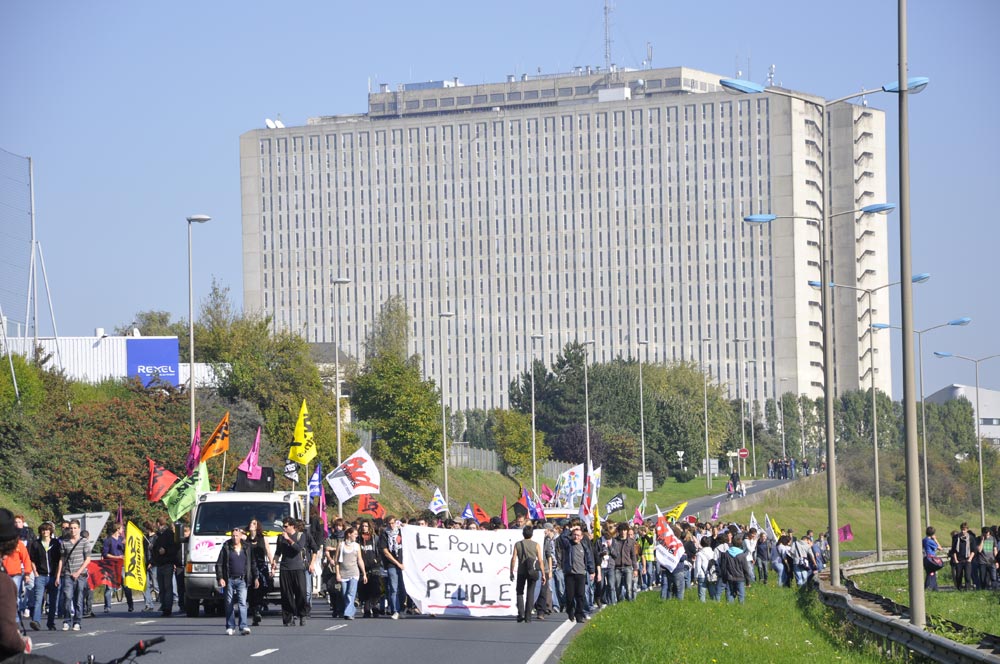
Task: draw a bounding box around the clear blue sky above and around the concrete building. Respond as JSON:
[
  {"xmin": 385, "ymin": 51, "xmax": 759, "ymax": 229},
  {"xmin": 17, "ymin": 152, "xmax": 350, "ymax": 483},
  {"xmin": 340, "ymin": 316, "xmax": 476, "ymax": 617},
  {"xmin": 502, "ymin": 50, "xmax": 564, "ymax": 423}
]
[{"xmin": 0, "ymin": 0, "xmax": 1000, "ymax": 399}]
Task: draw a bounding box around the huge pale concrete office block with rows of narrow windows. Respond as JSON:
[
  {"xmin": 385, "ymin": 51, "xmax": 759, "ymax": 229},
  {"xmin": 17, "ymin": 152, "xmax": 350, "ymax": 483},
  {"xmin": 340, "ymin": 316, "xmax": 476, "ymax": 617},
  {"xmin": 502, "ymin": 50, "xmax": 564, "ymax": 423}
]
[{"xmin": 240, "ymin": 67, "xmax": 895, "ymax": 409}]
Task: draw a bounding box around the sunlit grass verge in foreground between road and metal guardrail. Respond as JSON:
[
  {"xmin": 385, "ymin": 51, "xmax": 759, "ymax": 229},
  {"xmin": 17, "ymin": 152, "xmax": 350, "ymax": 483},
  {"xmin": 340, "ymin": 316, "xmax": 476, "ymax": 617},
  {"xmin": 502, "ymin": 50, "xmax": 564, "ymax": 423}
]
[{"xmin": 561, "ymin": 584, "xmax": 884, "ymax": 664}]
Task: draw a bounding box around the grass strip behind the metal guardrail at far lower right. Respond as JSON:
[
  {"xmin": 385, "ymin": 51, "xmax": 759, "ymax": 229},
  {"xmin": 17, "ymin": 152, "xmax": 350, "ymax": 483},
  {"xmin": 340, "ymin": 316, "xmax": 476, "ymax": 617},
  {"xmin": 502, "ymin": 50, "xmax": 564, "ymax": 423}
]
[{"xmin": 851, "ymin": 566, "xmax": 1000, "ymax": 643}]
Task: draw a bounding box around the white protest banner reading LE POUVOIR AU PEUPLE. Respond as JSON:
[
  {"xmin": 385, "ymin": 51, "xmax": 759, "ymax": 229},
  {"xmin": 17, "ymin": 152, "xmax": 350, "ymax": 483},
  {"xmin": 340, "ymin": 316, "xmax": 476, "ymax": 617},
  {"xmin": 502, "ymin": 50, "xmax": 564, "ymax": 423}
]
[{"xmin": 403, "ymin": 526, "xmax": 545, "ymax": 616}]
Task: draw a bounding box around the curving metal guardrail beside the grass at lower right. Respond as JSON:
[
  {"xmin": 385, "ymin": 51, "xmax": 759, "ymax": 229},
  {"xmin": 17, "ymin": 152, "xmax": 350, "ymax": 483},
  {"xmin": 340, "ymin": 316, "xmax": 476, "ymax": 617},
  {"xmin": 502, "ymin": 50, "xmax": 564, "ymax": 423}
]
[{"xmin": 818, "ymin": 560, "xmax": 1000, "ymax": 664}]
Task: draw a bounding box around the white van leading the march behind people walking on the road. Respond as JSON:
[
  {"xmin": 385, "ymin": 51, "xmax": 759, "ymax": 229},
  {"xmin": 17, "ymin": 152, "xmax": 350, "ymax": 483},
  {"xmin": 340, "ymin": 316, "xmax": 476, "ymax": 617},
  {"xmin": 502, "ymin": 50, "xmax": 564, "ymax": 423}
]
[{"xmin": 184, "ymin": 491, "xmax": 309, "ymax": 618}]
